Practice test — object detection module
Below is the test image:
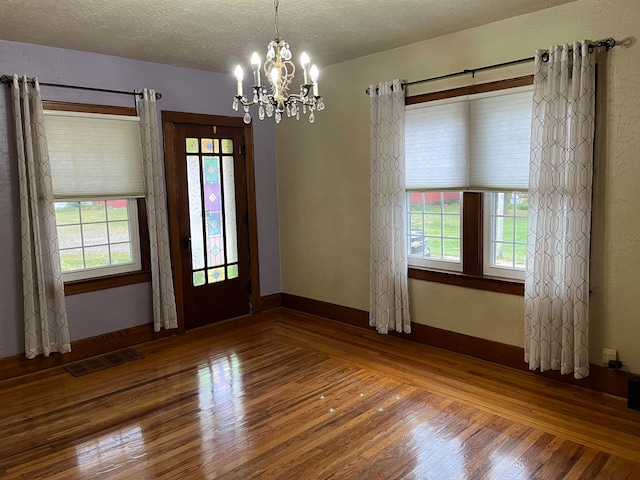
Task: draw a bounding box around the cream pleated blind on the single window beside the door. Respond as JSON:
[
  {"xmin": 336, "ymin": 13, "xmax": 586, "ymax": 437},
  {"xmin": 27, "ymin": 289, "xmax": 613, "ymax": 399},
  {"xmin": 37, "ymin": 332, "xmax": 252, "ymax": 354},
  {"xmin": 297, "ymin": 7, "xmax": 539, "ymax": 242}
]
[{"xmin": 44, "ymin": 110, "xmax": 144, "ymax": 199}]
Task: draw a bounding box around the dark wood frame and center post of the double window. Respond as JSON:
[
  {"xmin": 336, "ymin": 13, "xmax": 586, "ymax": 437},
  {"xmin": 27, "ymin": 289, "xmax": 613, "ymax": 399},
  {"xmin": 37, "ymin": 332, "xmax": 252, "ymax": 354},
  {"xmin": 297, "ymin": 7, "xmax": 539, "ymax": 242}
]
[{"xmin": 405, "ymin": 75, "xmax": 533, "ymax": 296}]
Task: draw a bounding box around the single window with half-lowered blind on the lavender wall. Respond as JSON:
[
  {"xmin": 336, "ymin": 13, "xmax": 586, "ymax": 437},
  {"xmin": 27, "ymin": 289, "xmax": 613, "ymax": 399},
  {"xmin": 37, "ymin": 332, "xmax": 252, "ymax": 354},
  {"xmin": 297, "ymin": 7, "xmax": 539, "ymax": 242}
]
[{"xmin": 45, "ymin": 102, "xmax": 148, "ymax": 293}]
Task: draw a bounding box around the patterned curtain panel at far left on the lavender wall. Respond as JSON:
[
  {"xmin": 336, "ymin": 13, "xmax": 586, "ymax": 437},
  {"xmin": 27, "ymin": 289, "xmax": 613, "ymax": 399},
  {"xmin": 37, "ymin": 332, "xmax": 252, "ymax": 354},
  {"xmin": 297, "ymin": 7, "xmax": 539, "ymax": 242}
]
[{"xmin": 11, "ymin": 75, "xmax": 71, "ymax": 358}]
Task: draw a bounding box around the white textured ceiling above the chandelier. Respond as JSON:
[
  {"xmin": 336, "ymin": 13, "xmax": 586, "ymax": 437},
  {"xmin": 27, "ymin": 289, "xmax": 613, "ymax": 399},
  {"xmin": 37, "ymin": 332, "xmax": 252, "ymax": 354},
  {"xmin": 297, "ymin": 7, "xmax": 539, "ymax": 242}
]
[{"xmin": 0, "ymin": 0, "xmax": 575, "ymax": 73}]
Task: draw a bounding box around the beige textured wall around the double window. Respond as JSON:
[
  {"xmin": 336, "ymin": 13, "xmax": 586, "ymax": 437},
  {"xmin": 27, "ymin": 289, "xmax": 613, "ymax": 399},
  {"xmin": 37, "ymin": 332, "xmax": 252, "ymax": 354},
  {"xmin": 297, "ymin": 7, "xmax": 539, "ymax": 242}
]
[{"xmin": 276, "ymin": 0, "xmax": 640, "ymax": 372}]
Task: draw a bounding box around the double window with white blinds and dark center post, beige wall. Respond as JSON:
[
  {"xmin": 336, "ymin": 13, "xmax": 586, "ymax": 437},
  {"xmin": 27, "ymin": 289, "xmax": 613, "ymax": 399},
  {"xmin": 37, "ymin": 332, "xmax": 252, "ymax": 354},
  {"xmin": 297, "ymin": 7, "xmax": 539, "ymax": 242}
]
[{"xmin": 405, "ymin": 77, "xmax": 532, "ymax": 279}]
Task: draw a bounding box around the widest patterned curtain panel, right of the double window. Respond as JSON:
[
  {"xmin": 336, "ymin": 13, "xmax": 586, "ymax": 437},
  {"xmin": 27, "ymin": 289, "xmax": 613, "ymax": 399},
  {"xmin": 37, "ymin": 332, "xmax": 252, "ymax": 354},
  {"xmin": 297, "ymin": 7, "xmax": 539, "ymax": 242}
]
[{"xmin": 525, "ymin": 42, "xmax": 595, "ymax": 378}]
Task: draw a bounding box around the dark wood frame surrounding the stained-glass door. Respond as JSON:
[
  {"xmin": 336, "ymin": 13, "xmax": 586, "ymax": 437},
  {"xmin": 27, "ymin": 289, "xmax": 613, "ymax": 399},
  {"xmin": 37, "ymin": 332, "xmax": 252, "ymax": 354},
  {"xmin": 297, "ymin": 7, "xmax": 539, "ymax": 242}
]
[{"xmin": 162, "ymin": 110, "xmax": 260, "ymax": 333}]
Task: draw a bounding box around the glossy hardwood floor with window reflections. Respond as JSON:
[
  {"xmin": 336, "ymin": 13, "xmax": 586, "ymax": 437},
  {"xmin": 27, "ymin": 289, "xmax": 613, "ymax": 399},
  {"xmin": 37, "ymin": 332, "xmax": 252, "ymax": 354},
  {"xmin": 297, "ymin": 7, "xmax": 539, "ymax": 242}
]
[{"xmin": 0, "ymin": 309, "xmax": 640, "ymax": 480}]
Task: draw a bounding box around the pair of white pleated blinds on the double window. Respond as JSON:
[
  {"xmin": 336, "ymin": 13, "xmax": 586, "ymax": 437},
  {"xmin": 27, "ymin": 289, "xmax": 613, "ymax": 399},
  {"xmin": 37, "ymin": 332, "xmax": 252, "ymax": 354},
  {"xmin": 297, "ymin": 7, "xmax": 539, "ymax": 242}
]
[{"xmin": 405, "ymin": 87, "xmax": 533, "ymax": 191}]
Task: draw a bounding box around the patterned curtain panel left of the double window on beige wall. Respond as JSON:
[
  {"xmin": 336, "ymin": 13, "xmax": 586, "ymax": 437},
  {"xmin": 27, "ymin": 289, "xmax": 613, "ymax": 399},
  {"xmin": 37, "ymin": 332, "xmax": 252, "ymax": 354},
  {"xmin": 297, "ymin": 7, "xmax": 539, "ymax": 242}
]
[{"xmin": 369, "ymin": 80, "xmax": 411, "ymax": 334}]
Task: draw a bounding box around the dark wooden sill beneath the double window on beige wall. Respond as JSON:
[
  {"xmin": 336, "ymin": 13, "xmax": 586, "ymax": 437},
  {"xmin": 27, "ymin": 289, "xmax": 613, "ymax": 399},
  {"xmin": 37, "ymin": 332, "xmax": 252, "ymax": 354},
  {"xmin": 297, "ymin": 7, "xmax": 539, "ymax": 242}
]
[{"xmin": 409, "ymin": 267, "xmax": 524, "ymax": 296}]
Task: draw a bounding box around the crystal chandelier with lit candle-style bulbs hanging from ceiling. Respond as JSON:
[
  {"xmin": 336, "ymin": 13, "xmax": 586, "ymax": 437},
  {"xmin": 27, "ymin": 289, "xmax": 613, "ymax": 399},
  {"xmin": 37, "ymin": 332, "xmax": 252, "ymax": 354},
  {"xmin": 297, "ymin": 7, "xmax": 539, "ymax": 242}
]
[{"xmin": 233, "ymin": 0, "xmax": 324, "ymax": 123}]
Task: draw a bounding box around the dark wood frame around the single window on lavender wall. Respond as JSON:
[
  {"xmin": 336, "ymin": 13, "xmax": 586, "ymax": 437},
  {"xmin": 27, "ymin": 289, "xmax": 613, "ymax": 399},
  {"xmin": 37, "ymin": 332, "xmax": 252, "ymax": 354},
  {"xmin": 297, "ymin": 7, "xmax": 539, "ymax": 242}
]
[{"xmin": 42, "ymin": 100, "xmax": 151, "ymax": 295}]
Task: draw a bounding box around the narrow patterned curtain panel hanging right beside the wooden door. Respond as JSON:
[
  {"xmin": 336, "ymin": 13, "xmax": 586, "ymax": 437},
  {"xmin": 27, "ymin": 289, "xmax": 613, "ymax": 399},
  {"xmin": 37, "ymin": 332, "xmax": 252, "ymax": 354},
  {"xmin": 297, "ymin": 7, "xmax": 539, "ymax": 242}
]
[{"xmin": 136, "ymin": 88, "xmax": 178, "ymax": 332}]
